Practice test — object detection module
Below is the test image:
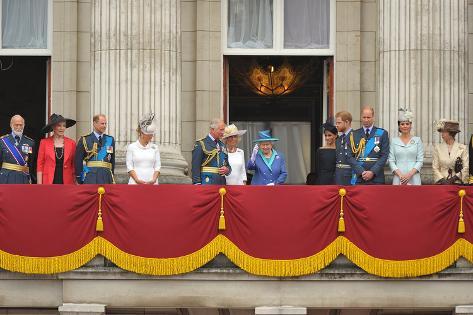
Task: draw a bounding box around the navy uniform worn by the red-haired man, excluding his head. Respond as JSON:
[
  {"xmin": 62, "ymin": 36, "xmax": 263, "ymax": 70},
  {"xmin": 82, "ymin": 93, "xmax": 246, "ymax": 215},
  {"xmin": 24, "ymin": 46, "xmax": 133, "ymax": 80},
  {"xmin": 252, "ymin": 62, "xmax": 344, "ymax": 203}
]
[{"xmin": 335, "ymin": 129, "xmax": 352, "ymax": 185}]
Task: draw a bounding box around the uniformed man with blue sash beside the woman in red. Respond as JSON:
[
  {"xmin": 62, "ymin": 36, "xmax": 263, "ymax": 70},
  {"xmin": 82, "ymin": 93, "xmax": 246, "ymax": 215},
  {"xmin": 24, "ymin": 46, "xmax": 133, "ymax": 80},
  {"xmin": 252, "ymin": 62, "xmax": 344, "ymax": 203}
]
[{"xmin": 75, "ymin": 114, "xmax": 115, "ymax": 184}]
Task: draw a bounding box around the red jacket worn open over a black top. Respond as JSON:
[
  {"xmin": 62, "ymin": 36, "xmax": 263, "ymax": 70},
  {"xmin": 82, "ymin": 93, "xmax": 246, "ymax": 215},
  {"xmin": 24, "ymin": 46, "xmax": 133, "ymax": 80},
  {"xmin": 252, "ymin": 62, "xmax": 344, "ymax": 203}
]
[{"xmin": 36, "ymin": 137, "xmax": 76, "ymax": 184}]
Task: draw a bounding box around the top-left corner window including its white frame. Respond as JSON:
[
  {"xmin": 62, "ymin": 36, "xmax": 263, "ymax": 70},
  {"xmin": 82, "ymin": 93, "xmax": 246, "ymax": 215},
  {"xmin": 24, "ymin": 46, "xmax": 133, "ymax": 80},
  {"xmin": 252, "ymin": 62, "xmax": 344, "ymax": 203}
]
[{"xmin": 0, "ymin": 0, "xmax": 52, "ymax": 55}]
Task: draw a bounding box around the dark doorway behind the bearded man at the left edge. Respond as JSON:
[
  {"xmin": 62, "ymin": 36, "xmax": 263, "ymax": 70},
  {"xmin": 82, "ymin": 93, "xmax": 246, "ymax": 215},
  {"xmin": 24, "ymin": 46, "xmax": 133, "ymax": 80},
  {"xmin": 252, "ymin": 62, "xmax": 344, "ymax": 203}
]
[{"xmin": 0, "ymin": 56, "xmax": 50, "ymax": 149}]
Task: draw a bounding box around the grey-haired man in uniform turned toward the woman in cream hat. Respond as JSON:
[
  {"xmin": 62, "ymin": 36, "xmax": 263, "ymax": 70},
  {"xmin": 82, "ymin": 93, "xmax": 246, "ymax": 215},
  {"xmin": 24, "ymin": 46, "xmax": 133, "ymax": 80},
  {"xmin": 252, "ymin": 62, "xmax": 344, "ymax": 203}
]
[{"xmin": 192, "ymin": 119, "xmax": 231, "ymax": 185}]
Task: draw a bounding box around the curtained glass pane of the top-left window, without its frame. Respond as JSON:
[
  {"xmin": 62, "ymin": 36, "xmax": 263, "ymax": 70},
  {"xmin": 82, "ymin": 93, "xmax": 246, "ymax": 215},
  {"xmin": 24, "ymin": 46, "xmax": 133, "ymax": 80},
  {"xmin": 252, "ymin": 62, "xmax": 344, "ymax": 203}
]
[{"xmin": 2, "ymin": 0, "xmax": 48, "ymax": 48}]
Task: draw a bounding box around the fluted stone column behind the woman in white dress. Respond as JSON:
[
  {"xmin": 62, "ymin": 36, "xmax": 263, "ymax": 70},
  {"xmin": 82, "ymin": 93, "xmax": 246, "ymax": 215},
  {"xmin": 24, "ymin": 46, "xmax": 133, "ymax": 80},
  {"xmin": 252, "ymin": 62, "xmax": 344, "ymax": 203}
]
[{"xmin": 91, "ymin": 0, "xmax": 190, "ymax": 183}]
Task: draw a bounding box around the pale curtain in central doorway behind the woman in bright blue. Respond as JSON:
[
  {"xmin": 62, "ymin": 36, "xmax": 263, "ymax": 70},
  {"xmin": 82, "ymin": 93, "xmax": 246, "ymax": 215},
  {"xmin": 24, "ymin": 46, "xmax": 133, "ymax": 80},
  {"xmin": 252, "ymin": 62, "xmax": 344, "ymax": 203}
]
[{"xmin": 233, "ymin": 121, "xmax": 310, "ymax": 184}]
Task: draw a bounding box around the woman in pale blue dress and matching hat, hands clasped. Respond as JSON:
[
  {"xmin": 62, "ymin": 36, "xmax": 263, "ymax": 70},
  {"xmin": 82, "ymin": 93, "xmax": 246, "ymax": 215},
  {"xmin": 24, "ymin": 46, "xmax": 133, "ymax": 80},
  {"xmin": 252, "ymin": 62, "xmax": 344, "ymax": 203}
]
[{"xmin": 389, "ymin": 109, "xmax": 424, "ymax": 185}]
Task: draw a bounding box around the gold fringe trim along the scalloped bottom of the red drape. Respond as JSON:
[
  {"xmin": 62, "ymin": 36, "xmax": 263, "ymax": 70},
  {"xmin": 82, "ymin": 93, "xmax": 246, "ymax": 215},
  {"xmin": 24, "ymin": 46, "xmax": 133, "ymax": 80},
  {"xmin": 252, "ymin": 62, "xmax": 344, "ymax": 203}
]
[{"xmin": 0, "ymin": 235, "xmax": 473, "ymax": 278}]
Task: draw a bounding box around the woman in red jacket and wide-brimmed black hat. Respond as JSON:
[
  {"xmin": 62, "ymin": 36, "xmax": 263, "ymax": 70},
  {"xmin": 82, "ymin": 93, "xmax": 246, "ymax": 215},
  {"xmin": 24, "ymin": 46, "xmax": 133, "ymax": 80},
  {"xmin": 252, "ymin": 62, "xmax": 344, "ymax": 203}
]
[{"xmin": 37, "ymin": 114, "xmax": 76, "ymax": 184}]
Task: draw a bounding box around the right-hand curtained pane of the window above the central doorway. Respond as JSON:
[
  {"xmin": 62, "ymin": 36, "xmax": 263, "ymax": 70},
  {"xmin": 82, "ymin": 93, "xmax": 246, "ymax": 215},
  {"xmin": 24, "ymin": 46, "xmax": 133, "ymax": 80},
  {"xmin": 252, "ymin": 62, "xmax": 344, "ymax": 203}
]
[{"xmin": 284, "ymin": 0, "xmax": 330, "ymax": 49}]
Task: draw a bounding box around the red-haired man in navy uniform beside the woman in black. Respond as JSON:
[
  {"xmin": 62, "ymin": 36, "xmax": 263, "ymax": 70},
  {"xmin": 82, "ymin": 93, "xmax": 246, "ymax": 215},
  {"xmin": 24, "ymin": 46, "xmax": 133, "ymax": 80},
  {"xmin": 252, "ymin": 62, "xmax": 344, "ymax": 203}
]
[{"xmin": 335, "ymin": 111, "xmax": 353, "ymax": 185}]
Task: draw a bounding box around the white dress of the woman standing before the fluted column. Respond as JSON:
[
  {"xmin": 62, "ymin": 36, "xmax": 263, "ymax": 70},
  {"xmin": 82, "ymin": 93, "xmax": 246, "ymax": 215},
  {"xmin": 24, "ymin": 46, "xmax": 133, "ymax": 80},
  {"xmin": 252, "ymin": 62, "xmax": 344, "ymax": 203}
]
[{"xmin": 126, "ymin": 141, "xmax": 161, "ymax": 185}]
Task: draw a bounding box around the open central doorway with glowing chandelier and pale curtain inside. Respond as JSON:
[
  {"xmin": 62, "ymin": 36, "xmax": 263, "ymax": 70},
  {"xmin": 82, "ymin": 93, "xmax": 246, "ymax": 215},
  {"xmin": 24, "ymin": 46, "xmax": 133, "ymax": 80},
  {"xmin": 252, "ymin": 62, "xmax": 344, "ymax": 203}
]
[{"xmin": 227, "ymin": 56, "xmax": 331, "ymax": 184}]
